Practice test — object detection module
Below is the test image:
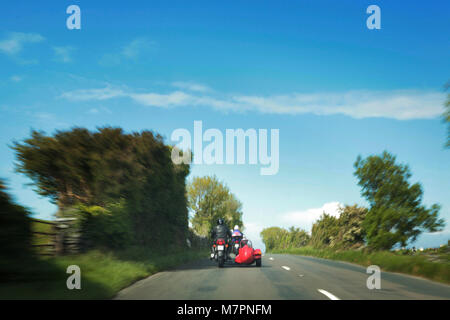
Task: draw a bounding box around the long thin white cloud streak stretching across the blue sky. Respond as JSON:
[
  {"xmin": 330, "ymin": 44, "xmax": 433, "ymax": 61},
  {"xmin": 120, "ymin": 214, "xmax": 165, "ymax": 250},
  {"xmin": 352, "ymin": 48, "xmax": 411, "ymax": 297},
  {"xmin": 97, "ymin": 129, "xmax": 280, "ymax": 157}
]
[{"xmin": 63, "ymin": 83, "xmax": 445, "ymax": 120}]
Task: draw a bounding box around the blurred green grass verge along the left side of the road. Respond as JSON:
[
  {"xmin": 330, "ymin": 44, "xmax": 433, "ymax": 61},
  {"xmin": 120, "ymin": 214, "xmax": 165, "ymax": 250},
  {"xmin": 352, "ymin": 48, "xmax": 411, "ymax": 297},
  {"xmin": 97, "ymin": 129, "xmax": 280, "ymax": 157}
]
[{"xmin": 0, "ymin": 248, "xmax": 207, "ymax": 299}]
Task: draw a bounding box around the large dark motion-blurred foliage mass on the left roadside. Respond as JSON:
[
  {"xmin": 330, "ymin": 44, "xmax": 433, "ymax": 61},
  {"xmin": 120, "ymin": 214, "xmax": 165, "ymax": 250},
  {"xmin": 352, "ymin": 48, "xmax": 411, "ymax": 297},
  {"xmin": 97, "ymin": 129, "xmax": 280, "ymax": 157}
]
[{"xmin": 13, "ymin": 127, "xmax": 189, "ymax": 246}]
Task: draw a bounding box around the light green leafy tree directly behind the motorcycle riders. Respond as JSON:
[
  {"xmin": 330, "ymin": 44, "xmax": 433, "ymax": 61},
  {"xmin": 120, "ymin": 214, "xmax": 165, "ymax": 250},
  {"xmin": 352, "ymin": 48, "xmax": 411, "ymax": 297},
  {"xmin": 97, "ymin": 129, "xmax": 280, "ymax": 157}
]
[{"xmin": 187, "ymin": 176, "xmax": 243, "ymax": 236}]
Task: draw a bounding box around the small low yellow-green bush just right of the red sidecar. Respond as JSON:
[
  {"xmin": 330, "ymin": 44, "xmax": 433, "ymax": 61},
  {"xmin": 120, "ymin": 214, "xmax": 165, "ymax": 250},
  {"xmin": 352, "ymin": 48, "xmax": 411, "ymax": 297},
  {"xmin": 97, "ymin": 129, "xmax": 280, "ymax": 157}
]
[{"xmin": 261, "ymin": 227, "xmax": 309, "ymax": 251}]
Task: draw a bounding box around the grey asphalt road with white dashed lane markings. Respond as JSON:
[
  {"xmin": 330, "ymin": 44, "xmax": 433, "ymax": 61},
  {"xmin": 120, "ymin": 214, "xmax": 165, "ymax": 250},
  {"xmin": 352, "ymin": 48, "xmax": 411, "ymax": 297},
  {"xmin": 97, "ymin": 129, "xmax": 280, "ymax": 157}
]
[{"xmin": 116, "ymin": 254, "xmax": 450, "ymax": 300}]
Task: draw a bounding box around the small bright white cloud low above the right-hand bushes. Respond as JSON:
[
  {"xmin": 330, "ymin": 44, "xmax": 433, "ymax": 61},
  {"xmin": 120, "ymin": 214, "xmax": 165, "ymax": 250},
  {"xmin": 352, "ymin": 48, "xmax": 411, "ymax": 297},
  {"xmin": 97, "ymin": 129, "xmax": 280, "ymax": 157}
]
[{"xmin": 281, "ymin": 202, "xmax": 342, "ymax": 232}]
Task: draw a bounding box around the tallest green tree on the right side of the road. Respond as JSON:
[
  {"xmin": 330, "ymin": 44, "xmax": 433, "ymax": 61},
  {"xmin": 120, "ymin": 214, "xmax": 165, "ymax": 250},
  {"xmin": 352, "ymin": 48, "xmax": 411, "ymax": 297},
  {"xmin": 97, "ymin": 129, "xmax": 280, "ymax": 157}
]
[{"xmin": 354, "ymin": 151, "xmax": 444, "ymax": 250}]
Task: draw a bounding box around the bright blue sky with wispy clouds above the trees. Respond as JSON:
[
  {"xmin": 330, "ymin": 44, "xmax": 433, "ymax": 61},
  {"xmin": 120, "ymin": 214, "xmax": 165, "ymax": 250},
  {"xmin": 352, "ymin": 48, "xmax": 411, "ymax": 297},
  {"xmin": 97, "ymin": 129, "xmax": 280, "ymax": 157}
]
[{"xmin": 0, "ymin": 0, "xmax": 450, "ymax": 250}]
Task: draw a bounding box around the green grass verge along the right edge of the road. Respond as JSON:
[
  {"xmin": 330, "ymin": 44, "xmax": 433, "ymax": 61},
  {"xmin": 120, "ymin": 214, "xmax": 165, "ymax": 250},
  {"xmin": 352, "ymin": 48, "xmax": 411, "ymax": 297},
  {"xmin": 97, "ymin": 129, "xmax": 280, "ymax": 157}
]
[{"xmin": 271, "ymin": 247, "xmax": 450, "ymax": 284}]
